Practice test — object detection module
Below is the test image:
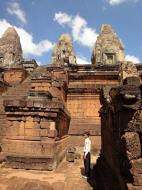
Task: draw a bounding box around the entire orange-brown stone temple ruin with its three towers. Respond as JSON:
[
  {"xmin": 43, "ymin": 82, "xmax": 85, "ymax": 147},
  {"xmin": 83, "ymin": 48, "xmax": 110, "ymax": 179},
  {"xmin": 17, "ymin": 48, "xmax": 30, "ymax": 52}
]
[{"xmin": 0, "ymin": 24, "xmax": 142, "ymax": 190}]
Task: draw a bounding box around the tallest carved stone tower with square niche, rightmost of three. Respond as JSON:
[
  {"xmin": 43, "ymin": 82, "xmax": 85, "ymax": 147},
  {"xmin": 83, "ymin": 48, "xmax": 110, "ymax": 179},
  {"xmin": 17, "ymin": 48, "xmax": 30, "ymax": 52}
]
[{"xmin": 92, "ymin": 24, "xmax": 125, "ymax": 65}]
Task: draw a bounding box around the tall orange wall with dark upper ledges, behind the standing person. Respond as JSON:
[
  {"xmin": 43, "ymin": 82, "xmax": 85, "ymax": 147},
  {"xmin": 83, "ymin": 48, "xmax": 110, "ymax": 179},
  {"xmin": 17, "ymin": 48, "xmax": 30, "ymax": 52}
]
[{"xmin": 67, "ymin": 65, "xmax": 118, "ymax": 149}]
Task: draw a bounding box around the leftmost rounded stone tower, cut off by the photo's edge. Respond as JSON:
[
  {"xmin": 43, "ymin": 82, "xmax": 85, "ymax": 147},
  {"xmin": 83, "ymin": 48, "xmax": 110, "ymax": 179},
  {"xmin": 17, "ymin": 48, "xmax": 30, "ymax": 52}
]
[{"xmin": 0, "ymin": 27, "xmax": 23, "ymax": 67}]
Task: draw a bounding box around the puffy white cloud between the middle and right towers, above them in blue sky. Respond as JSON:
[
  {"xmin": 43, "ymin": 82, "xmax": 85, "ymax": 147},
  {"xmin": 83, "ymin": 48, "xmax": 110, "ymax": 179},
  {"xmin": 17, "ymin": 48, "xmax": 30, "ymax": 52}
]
[{"xmin": 54, "ymin": 12, "xmax": 98, "ymax": 48}]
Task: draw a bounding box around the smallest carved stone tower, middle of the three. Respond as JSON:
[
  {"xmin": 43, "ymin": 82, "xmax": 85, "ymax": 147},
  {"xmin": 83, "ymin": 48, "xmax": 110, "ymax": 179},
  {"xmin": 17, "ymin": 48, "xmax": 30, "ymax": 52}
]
[{"xmin": 52, "ymin": 33, "xmax": 76, "ymax": 65}]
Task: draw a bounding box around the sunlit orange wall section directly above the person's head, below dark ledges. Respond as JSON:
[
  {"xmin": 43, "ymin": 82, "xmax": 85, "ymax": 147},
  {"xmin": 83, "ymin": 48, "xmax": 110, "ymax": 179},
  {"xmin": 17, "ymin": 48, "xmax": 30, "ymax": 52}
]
[{"xmin": 67, "ymin": 94, "xmax": 100, "ymax": 136}]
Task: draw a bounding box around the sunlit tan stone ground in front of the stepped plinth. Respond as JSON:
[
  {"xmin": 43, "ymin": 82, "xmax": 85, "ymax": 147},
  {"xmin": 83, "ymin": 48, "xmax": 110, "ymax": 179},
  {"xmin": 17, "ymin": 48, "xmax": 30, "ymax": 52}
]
[{"xmin": 0, "ymin": 151, "xmax": 98, "ymax": 190}]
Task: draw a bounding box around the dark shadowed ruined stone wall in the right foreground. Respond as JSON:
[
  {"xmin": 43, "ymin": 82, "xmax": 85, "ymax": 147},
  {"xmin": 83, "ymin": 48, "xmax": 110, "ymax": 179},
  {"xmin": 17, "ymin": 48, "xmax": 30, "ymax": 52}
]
[{"xmin": 95, "ymin": 64, "xmax": 142, "ymax": 190}]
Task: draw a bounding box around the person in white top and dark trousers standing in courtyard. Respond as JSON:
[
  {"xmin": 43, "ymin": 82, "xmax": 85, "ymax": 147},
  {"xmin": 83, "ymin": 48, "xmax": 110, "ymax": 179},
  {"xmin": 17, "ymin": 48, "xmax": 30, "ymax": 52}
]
[{"xmin": 83, "ymin": 132, "xmax": 91, "ymax": 179}]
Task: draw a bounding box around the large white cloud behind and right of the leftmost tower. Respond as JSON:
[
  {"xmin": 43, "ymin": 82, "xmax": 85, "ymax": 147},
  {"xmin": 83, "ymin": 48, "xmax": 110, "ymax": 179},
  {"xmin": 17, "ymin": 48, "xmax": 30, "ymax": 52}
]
[{"xmin": 0, "ymin": 19, "xmax": 54, "ymax": 57}]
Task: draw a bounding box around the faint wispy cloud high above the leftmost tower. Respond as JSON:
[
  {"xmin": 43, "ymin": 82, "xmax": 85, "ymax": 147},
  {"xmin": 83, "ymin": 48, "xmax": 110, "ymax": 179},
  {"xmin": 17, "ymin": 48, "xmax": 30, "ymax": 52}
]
[{"xmin": 7, "ymin": 2, "xmax": 27, "ymax": 24}]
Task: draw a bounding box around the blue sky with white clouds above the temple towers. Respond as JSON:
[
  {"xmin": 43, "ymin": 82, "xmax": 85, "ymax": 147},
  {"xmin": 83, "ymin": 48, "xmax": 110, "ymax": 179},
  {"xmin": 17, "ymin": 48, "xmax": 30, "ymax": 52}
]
[{"xmin": 0, "ymin": 0, "xmax": 142, "ymax": 64}]
